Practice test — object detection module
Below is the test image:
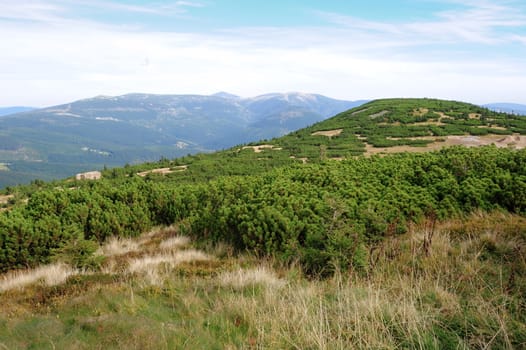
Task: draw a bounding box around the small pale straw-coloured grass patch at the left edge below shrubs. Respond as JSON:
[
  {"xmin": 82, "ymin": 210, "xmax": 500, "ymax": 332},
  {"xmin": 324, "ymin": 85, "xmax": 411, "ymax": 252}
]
[{"xmin": 0, "ymin": 263, "xmax": 81, "ymax": 292}]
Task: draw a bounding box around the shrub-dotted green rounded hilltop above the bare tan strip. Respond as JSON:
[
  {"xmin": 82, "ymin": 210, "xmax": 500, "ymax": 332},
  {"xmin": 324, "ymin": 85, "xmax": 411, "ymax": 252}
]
[{"xmin": 275, "ymin": 99, "xmax": 526, "ymax": 159}]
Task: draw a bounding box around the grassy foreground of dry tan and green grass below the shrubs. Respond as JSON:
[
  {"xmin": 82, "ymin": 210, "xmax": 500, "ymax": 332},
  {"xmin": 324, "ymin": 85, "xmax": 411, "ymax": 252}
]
[{"xmin": 0, "ymin": 212, "xmax": 526, "ymax": 349}]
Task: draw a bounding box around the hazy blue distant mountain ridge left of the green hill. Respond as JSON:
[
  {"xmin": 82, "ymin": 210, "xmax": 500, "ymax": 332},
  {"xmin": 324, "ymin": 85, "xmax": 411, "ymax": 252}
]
[{"xmin": 0, "ymin": 92, "xmax": 365, "ymax": 187}]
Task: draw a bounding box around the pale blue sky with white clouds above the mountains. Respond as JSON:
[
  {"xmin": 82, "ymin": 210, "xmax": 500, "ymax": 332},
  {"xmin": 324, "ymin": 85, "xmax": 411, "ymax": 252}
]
[{"xmin": 0, "ymin": 0, "xmax": 526, "ymax": 107}]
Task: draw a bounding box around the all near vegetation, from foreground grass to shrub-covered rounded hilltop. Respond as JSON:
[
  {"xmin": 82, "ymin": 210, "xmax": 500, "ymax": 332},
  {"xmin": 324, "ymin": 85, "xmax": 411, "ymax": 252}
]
[{"xmin": 0, "ymin": 99, "xmax": 526, "ymax": 349}]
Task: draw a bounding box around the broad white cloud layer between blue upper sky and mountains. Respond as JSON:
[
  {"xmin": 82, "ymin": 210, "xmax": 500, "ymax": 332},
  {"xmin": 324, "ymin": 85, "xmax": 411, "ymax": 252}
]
[{"xmin": 0, "ymin": 0, "xmax": 526, "ymax": 105}]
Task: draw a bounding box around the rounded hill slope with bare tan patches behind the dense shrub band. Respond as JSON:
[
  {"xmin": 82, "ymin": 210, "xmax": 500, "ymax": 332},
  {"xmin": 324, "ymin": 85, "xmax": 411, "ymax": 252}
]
[{"xmin": 113, "ymin": 95, "xmax": 526, "ymax": 182}]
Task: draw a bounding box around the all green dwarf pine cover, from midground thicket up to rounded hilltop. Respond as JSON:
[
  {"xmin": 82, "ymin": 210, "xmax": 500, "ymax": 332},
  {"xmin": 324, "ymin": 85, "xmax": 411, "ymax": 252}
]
[{"xmin": 0, "ymin": 99, "xmax": 526, "ymax": 273}]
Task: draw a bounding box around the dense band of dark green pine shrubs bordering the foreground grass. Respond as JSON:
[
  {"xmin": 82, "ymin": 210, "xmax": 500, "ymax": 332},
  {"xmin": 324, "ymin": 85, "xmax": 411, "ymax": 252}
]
[{"xmin": 0, "ymin": 146, "xmax": 526, "ymax": 274}]
